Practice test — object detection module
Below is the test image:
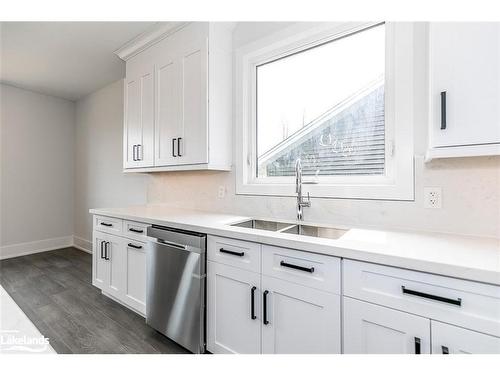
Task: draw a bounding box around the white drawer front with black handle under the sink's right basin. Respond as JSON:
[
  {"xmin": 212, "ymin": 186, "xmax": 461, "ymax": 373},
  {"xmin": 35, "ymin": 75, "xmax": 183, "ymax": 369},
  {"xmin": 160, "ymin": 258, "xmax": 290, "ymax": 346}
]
[{"xmin": 262, "ymin": 245, "xmax": 340, "ymax": 294}]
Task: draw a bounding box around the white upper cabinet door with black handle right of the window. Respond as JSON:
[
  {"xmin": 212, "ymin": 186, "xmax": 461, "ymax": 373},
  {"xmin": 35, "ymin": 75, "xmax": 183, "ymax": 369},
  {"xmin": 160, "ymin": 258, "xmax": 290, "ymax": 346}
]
[{"xmin": 429, "ymin": 22, "xmax": 500, "ymax": 147}]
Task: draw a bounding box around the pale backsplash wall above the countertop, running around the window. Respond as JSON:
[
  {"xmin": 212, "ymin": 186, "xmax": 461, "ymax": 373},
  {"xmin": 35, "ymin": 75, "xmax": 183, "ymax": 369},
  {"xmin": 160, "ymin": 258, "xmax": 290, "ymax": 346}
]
[{"xmin": 148, "ymin": 24, "xmax": 500, "ymax": 237}]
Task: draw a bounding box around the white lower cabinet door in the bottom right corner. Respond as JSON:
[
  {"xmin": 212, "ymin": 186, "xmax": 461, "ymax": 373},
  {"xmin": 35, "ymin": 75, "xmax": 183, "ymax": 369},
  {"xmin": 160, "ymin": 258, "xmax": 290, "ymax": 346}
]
[{"xmin": 431, "ymin": 321, "xmax": 500, "ymax": 354}]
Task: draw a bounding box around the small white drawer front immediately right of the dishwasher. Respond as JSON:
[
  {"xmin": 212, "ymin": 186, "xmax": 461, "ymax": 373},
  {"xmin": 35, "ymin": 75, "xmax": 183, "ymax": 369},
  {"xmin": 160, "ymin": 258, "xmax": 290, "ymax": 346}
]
[{"xmin": 207, "ymin": 236, "xmax": 261, "ymax": 272}]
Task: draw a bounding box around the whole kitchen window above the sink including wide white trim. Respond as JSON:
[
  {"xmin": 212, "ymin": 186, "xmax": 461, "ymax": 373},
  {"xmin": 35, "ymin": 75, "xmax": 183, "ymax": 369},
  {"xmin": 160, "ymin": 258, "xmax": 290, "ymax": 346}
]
[{"xmin": 236, "ymin": 23, "xmax": 413, "ymax": 200}]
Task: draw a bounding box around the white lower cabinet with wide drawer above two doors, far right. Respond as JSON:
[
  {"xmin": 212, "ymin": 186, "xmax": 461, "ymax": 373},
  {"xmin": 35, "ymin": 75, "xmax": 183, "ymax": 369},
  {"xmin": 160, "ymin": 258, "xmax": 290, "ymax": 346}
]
[{"xmin": 342, "ymin": 260, "xmax": 500, "ymax": 354}]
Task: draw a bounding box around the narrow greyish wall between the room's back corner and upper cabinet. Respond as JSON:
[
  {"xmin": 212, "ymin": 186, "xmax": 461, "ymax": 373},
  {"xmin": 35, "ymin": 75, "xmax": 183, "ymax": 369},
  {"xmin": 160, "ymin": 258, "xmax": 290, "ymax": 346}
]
[{"xmin": 74, "ymin": 80, "xmax": 148, "ymax": 248}]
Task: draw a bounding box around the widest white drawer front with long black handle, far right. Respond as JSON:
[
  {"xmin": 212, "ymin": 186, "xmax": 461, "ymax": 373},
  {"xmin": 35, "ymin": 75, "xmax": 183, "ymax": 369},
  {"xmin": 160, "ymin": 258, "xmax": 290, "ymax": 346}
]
[{"xmin": 343, "ymin": 260, "xmax": 500, "ymax": 336}]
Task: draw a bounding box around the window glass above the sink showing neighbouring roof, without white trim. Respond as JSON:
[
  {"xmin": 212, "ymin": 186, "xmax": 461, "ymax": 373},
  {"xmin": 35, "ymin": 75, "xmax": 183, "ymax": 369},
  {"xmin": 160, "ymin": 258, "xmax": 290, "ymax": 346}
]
[{"xmin": 256, "ymin": 24, "xmax": 385, "ymax": 178}]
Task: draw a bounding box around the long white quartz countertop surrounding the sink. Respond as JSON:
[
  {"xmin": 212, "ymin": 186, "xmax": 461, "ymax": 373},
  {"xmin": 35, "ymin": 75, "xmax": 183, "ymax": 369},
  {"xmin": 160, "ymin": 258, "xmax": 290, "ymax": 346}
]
[{"xmin": 90, "ymin": 205, "xmax": 500, "ymax": 285}]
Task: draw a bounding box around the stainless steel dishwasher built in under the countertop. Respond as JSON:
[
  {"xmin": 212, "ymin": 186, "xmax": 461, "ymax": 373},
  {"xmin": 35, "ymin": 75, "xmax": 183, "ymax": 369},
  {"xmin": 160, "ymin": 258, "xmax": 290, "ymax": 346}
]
[{"xmin": 146, "ymin": 225, "xmax": 207, "ymax": 353}]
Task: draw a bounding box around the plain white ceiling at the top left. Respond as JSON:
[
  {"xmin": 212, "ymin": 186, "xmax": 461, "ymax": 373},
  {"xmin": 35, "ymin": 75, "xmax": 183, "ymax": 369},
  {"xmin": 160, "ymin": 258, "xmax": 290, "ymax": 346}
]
[{"xmin": 0, "ymin": 22, "xmax": 155, "ymax": 100}]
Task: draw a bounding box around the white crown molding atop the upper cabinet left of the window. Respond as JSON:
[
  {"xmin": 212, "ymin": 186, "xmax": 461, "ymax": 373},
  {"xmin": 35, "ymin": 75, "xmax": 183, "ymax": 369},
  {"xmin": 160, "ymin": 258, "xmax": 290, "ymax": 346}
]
[{"xmin": 114, "ymin": 22, "xmax": 188, "ymax": 61}]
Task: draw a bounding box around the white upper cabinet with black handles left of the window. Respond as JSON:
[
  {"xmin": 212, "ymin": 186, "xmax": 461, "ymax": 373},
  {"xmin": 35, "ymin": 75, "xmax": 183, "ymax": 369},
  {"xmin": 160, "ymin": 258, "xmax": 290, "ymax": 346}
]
[{"xmin": 117, "ymin": 22, "xmax": 232, "ymax": 172}]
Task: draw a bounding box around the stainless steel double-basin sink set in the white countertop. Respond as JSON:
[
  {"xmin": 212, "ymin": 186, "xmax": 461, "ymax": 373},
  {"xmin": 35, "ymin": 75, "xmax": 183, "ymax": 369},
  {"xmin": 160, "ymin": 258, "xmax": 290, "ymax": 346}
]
[{"xmin": 231, "ymin": 219, "xmax": 347, "ymax": 240}]
